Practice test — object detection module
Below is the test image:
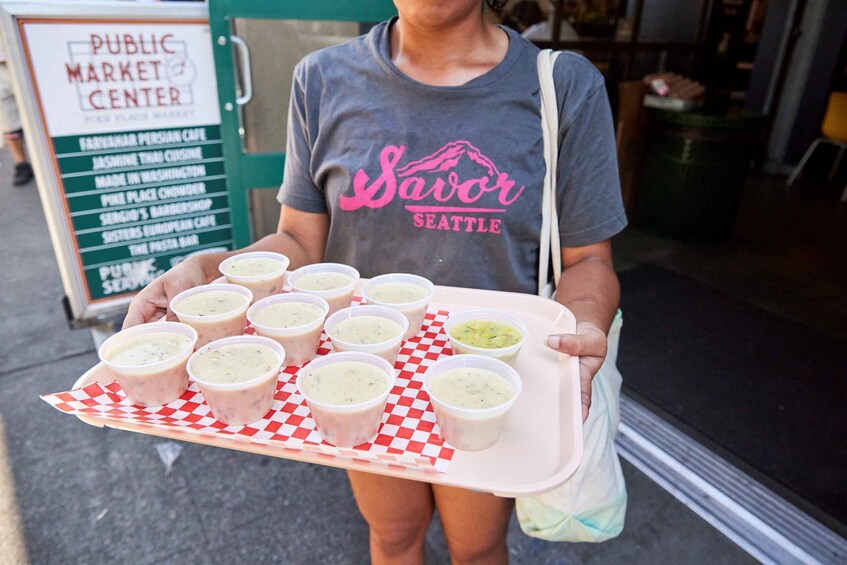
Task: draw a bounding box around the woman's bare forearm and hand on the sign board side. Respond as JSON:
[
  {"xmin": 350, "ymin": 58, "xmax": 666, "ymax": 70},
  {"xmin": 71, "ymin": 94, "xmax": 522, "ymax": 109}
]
[{"xmin": 124, "ymin": 206, "xmax": 329, "ymax": 328}]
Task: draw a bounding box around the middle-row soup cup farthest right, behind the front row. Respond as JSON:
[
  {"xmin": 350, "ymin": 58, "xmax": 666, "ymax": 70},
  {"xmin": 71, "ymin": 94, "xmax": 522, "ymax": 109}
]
[{"xmin": 324, "ymin": 304, "xmax": 409, "ymax": 365}]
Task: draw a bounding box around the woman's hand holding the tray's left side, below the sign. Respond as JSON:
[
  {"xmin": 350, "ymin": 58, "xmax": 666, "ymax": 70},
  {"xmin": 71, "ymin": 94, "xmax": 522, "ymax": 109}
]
[{"xmin": 123, "ymin": 256, "xmax": 209, "ymax": 329}]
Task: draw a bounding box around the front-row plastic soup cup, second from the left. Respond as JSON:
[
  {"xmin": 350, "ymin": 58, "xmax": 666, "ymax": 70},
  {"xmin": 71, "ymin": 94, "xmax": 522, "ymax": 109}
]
[{"xmin": 187, "ymin": 335, "xmax": 285, "ymax": 426}]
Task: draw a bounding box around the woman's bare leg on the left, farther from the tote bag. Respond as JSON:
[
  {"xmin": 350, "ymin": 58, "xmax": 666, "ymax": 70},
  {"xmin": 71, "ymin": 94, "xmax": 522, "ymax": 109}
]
[{"xmin": 347, "ymin": 471, "xmax": 433, "ymax": 565}]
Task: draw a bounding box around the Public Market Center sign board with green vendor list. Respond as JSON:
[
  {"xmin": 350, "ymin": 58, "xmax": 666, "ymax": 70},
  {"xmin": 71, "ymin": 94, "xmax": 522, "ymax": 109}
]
[{"xmin": 0, "ymin": 4, "xmax": 233, "ymax": 319}]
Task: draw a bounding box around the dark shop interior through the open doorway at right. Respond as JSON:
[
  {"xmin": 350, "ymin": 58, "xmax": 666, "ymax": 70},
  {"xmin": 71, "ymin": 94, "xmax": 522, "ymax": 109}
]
[{"xmin": 504, "ymin": 0, "xmax": 847, "ymax": 531}]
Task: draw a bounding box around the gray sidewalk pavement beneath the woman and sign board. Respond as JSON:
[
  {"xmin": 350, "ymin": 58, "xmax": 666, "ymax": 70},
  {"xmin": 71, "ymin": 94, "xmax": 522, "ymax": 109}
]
[{"xmin": 0, "ymin": 153, "xmax": 754, "ymax": 565}]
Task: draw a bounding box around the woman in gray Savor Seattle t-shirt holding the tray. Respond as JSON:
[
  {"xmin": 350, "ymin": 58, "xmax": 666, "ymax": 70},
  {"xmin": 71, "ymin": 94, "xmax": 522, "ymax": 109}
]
[{"xmin": 125, "ymin": 0, "xmax": 626, "ymax": 563}]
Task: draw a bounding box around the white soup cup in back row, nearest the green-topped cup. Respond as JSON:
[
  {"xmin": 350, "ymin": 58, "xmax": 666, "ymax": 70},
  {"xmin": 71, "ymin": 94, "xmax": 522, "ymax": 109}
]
[{"xmin": 362, "ymin": 273, "xmax": 435, "ymax": 339}]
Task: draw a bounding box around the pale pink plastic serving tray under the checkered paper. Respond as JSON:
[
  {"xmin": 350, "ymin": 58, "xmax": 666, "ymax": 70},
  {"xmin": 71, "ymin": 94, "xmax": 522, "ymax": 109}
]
[{"xmin": 51, "ymin": 287, "xmax": 582, "ymax": 497}]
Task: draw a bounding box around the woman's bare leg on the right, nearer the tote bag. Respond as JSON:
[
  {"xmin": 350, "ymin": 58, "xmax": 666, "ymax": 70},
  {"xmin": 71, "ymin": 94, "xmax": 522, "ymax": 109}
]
[{"xmin": 432, "ymin": 485, "xmax": 515, "ymax": 565}]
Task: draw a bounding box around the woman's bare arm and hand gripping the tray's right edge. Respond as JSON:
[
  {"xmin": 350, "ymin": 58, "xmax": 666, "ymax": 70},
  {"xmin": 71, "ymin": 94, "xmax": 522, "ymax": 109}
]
[{"xmin": 547, "ymin": 240, "xmax": 621, "ymax": 421}]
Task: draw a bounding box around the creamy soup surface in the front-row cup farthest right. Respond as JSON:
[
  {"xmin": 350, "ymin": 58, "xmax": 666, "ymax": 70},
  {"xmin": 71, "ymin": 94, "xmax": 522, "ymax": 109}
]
[{"xmin": 429, "ymin": 367, "xmax": 515, "ymax": 409}]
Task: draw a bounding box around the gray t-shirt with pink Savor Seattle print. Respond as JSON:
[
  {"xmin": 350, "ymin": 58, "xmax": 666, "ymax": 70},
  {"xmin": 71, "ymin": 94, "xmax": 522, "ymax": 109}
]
[{"xmin": 278, "ymin": 22, "xmax": 626, "ymax": 293}]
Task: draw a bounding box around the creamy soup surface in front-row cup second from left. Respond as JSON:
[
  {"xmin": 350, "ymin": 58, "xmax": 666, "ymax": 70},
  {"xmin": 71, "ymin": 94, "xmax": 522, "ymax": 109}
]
[{"xmin": 191, "ymin": 344, "xmax": 279, "ymax": 384}]
